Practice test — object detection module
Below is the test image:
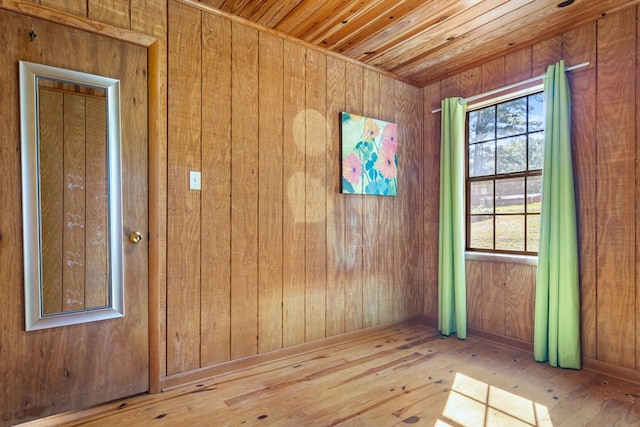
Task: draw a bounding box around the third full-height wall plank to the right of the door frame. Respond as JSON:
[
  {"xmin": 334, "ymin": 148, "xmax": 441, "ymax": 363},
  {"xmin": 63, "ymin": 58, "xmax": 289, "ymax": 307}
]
[{"xmin": 231, "ymin": 23, "xmax": 259, "ymax": 359}]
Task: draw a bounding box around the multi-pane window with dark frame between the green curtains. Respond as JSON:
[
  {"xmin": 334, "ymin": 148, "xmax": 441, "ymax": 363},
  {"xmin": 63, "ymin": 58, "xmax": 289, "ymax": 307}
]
[{"xmin": 466, "ymin": 92, "xmax": 544, "ymax": 255}]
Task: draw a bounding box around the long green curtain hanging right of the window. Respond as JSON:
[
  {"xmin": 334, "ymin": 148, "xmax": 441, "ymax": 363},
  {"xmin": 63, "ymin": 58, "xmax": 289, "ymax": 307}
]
[{"xmin": 533, "ymin": 61, "xmax": 580, "ymax": 369}]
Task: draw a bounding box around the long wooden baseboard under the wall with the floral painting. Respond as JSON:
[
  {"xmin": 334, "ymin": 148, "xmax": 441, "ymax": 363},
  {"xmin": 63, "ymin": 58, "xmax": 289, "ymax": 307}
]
[{"xmin": 161, "ymin": 318, "xmax": 424, "ymax": 391}]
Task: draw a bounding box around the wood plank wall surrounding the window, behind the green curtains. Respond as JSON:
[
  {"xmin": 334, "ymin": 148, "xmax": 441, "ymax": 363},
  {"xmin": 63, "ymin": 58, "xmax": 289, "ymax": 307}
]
[{"xmin": 423, "ymin": 7, "xmax": 640, "ymax": 369}]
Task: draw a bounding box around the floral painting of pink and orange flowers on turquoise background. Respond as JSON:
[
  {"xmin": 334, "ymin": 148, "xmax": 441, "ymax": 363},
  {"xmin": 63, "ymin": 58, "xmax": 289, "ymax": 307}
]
[{"xmin": 340, "ymin": 112, "xmax": 398, "ymax": 196}]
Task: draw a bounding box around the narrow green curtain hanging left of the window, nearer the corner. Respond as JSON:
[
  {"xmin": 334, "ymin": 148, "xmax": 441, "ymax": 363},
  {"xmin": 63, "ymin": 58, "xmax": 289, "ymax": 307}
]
[{"xmin": 438, "ymin": 98, "xmax": 467, "ymax": 339}]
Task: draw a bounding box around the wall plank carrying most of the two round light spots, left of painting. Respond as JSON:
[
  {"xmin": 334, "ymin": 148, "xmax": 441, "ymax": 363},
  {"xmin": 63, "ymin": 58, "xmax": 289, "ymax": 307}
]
[{"xmin": 304, "ymin": 49, "xmax": 327, "ymax": 341}]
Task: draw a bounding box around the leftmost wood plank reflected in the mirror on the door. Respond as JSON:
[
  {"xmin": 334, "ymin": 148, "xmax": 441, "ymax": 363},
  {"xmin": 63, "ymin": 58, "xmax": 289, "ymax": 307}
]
[{"xmin": 38, "ymin": 90, "xmax": 64, "ymax": 313}]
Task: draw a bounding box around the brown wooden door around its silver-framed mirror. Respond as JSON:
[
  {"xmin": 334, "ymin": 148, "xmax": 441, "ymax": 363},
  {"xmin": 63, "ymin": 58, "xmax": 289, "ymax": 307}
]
[{"xmin": 0, "ymin": 11, "xmax": 149, "ymax": 425}]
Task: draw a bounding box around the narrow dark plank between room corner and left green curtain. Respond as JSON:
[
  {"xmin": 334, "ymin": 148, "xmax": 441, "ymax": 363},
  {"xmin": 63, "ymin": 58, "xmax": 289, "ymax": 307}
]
[{"xmin": 422, "ymin": 83, "xmax": 441, "ymax": 325}]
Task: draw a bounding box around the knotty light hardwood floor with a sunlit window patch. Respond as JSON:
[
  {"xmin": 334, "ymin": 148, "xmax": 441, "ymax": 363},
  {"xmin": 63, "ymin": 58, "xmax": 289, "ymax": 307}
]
[{"xmin": 20, "ymin": 322, "xmax": 640, "ymax": 427}]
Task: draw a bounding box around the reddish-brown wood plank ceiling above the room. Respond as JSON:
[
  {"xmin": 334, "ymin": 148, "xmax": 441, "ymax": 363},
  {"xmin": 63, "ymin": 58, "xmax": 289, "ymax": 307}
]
[{"xmin": 200, "ymin": 0, "xmax": 640, "ymax": 87}]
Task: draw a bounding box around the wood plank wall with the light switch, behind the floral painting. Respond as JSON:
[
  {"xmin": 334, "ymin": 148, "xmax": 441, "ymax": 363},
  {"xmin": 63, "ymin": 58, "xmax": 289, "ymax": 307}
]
[{"xmin": 166, "ymin": 1, "xmax": 423, "ymax": 376}]
